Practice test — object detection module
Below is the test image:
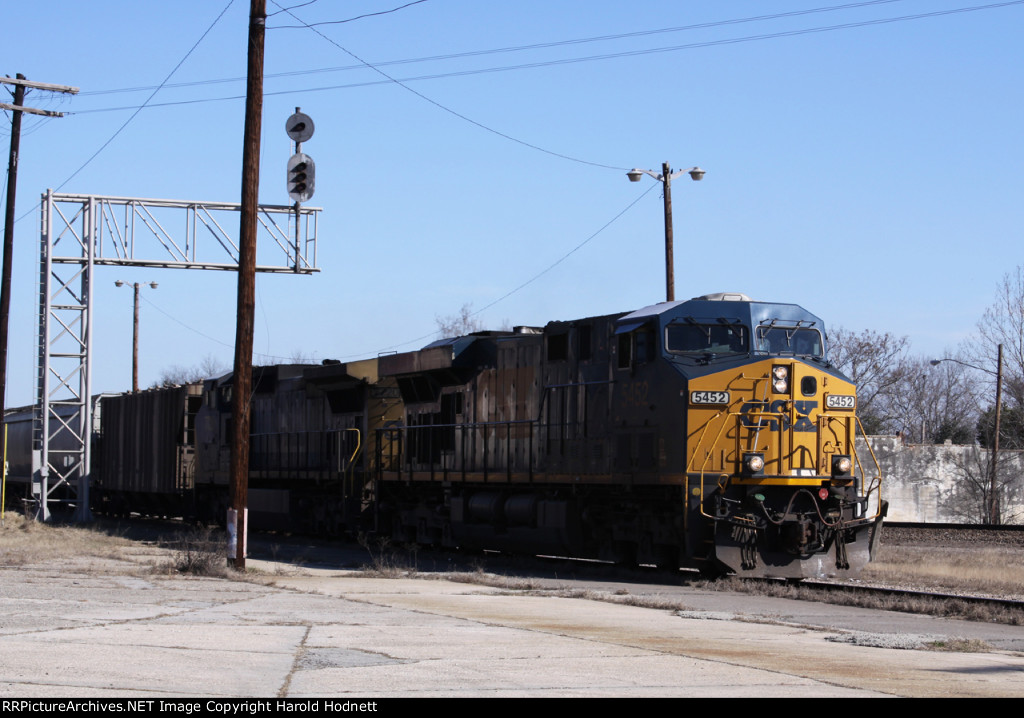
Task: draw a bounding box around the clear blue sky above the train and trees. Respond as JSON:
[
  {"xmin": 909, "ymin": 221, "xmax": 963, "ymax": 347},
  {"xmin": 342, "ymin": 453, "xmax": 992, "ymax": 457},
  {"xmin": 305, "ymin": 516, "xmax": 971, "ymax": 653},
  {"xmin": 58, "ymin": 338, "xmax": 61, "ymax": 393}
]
[{"xmin": 0, "ymin": 0, "xmax": 1024, "ymax": 406}]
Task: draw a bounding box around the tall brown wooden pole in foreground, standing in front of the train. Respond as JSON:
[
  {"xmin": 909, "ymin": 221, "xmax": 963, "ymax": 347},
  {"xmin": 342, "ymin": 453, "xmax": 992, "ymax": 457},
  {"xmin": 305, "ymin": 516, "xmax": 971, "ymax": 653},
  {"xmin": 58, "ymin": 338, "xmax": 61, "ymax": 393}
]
[{"xmin": 228, "ymin": 0, "xmax": 266, "ymax": 571}]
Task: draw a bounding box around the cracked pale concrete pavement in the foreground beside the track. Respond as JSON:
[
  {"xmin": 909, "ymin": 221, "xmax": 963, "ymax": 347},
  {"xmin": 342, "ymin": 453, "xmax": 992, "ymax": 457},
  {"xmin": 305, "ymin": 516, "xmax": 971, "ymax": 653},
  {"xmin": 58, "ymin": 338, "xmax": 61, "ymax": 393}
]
[{"xmin": 0, "ymin": 548, "xmax": 1024, "ymax": 699}]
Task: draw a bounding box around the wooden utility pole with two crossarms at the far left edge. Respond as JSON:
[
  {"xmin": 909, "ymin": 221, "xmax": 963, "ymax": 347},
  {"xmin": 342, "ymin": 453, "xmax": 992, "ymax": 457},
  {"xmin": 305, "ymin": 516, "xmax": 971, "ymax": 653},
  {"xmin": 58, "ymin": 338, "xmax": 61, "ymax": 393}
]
[{"xmin": 0, "ymin": 73, "xmax": 78, "ymax": 412}]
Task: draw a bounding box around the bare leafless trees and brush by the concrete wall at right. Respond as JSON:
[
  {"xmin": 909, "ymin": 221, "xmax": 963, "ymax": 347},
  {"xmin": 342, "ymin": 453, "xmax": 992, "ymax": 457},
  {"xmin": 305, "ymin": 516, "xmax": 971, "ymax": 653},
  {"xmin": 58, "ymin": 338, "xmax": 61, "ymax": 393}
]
[{"xmin": 828, "ymin": 266, "xmax": 1024, "ymax": 523}]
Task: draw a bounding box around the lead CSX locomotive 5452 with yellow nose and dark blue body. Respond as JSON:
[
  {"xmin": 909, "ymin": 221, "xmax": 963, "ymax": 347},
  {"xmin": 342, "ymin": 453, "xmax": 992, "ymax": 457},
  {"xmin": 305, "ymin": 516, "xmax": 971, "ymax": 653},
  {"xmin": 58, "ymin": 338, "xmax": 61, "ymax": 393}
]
[{"xmin": 375, "ymin": 294, "xmax": 885, "ymax": 578}]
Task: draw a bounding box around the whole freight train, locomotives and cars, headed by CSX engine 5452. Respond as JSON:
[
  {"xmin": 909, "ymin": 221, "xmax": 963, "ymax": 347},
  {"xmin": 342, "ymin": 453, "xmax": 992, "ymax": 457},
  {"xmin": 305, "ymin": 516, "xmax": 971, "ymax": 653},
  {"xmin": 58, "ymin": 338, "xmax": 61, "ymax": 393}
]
[{"xmin": 16, "ymin": 294, "xmax": 886, "ymax": 578}]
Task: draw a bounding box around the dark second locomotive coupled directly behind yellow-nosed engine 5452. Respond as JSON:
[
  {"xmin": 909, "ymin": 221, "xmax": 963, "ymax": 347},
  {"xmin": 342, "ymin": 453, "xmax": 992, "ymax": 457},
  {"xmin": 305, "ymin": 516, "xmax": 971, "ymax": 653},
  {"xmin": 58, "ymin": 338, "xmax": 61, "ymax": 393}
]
[{"xmin": 196, "ymin": 358, "xmax": 402, "ymax": 536}]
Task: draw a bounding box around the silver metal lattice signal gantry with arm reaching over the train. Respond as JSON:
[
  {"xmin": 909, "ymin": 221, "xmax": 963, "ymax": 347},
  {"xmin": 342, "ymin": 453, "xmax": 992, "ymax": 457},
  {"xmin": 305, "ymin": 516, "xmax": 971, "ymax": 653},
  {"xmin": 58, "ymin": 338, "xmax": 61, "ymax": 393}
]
[{"xmin": 32, "ymin": 191, "xmax": 322, "ymax": 520}]
